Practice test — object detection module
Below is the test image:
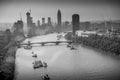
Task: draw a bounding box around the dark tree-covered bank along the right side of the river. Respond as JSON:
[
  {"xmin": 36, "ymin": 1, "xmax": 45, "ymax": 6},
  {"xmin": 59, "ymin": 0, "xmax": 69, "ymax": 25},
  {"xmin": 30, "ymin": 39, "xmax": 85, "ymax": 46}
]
[{"xmin": 65, "ymin": 34, "xmax": 120, "ymax": 57}]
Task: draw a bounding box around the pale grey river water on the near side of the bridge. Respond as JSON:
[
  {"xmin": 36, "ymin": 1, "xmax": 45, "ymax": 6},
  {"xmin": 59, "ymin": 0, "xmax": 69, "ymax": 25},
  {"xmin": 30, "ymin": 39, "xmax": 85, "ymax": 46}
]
[{"xmin": 15, "ymin": 33, "xmax": 120, "ymax": 80}]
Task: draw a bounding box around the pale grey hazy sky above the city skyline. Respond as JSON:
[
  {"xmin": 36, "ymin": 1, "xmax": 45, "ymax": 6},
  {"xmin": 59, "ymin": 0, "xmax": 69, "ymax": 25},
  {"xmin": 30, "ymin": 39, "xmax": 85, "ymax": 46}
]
[{"xmin": 0, "ymin": 0, "xmax": 120, "ymax": 23}]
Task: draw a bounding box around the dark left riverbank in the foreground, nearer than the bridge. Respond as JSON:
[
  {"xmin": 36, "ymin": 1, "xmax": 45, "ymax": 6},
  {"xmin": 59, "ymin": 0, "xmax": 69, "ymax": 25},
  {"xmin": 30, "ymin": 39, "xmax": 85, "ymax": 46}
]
[{"xmin": 0, "ymin": 46, "xmax": 16, "ymax": 80}]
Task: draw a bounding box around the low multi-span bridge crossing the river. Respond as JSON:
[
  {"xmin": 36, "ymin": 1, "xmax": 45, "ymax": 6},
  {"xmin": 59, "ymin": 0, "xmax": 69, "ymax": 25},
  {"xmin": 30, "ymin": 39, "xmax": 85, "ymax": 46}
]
[{"xmin": 17, "ymin": 41, "xmax": 73, "ymax": 47}]
